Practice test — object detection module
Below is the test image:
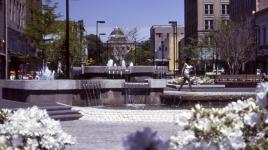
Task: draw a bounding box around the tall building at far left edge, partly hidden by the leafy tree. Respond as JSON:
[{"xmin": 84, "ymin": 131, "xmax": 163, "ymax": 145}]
[{"xmin": 0, "ymin": 0, "xmax": 41, "ymax": 79}]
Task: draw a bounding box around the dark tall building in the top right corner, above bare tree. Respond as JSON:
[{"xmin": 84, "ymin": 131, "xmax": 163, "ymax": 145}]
[{"xmin": 230, "ymin": 0, "xmax": 268, "ymax": 21}]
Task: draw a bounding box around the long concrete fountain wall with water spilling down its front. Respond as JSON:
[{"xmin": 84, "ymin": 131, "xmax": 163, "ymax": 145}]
[{"xmin": 0, "ymin": 79, "xmax": 166, "ymax": 106}]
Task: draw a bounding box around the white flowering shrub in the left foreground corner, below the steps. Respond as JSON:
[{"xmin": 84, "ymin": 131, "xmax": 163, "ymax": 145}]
[{"xmin": 0, "ymin": 107, "xmax": 75, "ymax": 150}]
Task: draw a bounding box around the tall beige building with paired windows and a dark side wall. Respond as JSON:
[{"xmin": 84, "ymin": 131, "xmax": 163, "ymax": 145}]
[{"xmin": 184, "ymin": 0, "xmax": 230, "ymax": 45}]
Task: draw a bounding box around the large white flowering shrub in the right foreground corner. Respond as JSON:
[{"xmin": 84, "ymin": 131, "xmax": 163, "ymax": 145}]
[{"xmin": 171, "ymin": 83, "xmax": 268, "ymax": 150}]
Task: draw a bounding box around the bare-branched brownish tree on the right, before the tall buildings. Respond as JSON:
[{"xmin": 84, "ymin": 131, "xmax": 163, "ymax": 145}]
[{"xmin": 206, "ymin": 21, "xmax": 255, "ymax": 74}]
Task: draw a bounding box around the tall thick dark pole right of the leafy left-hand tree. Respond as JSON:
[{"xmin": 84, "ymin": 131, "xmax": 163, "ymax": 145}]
[{"xmin": 65, "ymin": 0, "xmax": 70, "ymax": 79}]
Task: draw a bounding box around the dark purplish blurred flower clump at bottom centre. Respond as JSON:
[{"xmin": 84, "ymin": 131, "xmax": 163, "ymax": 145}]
[{"xmin": 124, "ymin": 128, "xmax": 169, "ymax": 150}]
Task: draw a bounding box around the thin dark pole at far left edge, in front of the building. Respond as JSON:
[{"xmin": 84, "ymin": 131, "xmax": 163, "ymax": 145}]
[{"xmin": 4, "ymin": 0, "xmax": 8, "ymax": 80}]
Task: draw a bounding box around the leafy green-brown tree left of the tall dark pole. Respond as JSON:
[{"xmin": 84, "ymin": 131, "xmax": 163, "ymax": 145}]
[{"xmin": 24, "ymin": 0, "xmax": 61, "ymax": 60}]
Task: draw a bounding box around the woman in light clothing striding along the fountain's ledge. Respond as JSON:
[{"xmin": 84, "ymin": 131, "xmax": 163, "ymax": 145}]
[{"xmin": 179, "ymin": 58, "xmax": 193, "ymax": 91}]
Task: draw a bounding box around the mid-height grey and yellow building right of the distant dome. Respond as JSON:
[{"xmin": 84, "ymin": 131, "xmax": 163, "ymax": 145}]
[{"xmin": 150, "ymin": 25, "xmax": 184, "ymax": 71}]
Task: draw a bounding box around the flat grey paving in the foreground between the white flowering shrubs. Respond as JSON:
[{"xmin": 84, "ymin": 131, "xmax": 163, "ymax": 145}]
[{"xmin": 61, "ymin": 120, "xmax": 178, "ymax": 150}]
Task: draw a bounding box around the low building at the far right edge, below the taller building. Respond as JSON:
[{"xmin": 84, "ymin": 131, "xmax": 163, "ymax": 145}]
[{"xmin": 255, "ymin": 8, "xmax": 268, "ymax": 73}]
